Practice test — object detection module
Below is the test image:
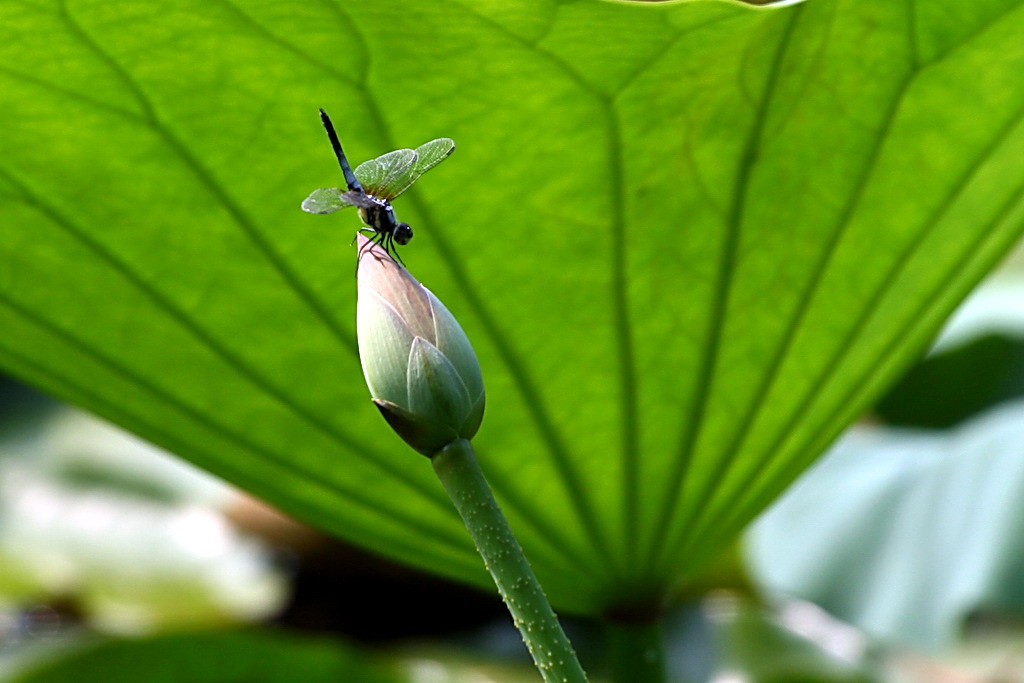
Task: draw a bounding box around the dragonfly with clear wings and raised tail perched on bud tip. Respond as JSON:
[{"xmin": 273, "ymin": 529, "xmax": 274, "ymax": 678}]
[{"xmin": 302, "ymin": 110, "xmax": 455, "ymax": 265}]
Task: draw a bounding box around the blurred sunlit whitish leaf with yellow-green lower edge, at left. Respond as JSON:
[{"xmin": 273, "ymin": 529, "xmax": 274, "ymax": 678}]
[{"xmin": 0, "ymin": 412, "xmax": 288, "ymax": 642}]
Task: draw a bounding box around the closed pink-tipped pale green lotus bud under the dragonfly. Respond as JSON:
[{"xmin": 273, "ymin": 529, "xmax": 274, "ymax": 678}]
[{"xmin": 355, "ymin": 236, "xmax": 483, "ymax": 457}]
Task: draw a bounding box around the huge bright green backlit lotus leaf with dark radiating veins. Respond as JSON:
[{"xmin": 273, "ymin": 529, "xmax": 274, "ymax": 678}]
[{"xmin": 0, "ymin": 0, "xmax": 1024, "ymax": 612}]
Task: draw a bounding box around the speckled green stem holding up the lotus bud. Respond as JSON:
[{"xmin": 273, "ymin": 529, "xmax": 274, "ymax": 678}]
[{"xmin": 430, "ymin": 439, "xmax": 587, "ymax": 683}]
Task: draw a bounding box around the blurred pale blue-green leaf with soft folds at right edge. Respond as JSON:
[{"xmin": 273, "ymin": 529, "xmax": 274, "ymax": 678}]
[{"xmin": 750, "ymin": 401, "xmax": 1024, "ymax": 650}]
